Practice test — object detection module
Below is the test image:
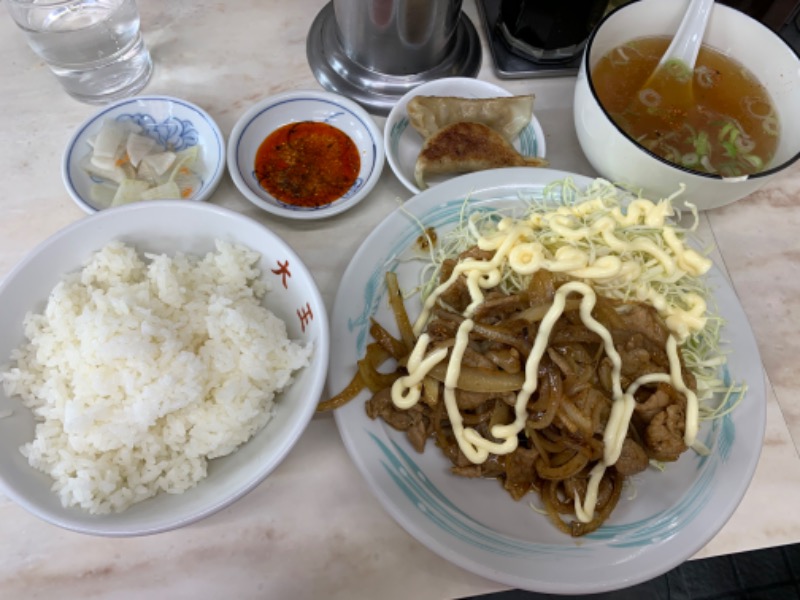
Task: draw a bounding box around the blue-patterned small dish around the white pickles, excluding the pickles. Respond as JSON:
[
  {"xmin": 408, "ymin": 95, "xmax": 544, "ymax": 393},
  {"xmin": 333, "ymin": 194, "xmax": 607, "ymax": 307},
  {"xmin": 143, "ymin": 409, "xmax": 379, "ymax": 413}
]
[{"xmin": 61, "ymin": 96, "xmax": 225, "ymax": 214}]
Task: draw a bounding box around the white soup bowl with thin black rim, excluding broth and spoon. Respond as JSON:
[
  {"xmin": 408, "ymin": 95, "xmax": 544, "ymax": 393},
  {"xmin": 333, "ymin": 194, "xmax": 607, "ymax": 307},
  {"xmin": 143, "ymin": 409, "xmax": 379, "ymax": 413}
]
[{"xmin": 574, "ymin": 0, "xmax": 800, "ymax": 210}]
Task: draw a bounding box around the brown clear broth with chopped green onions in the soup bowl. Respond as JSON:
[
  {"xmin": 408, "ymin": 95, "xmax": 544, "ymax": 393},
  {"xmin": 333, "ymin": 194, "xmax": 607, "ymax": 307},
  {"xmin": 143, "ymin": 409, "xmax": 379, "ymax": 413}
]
[{"xmin": 592, "ymin": 36, "xmax": 779, "ymax": 177}]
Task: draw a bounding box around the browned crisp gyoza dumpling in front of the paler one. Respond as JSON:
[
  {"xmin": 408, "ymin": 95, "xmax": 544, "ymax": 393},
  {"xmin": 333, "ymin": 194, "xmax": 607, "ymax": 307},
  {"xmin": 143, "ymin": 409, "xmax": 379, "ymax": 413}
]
[{"xmin": 414, "ymin": 122, "xmax": 547, "ymax": 189}]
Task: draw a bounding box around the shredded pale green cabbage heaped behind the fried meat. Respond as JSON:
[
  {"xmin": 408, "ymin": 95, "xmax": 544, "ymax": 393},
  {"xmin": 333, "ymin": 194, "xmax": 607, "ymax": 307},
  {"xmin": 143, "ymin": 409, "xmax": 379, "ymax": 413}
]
[{"xmin": 412, "ymin": 179, "xmax": 747, "ymax": 426}]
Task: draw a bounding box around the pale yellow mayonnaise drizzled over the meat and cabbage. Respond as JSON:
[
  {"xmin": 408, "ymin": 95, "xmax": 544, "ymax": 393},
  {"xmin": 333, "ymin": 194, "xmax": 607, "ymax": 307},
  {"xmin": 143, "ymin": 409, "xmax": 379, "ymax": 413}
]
[{"xmin": 392, "ymin": 192, "xmax": 711, "ymax": 522}]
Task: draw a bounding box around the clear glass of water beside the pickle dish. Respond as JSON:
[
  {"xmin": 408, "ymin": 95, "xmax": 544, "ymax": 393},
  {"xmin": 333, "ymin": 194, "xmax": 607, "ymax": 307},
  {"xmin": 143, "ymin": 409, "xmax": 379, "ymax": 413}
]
[{"xmin": 6, "ymin": 0, "xmax": 153, "ymax": 104}]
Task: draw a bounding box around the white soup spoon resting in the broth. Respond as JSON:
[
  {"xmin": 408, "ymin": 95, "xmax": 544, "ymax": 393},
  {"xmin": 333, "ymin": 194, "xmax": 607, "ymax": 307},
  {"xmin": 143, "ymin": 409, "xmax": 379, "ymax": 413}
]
[{"xmin": 641, "ymin": 0, "xmax": 714, "ymax": 106}]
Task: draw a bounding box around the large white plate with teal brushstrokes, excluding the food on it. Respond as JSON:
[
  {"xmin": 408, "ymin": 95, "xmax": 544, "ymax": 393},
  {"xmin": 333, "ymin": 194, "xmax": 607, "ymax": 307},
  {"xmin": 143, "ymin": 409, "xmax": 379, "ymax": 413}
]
[{"xmin": 328, "ymin": 168, "xmax": 766, "ymax": 594}]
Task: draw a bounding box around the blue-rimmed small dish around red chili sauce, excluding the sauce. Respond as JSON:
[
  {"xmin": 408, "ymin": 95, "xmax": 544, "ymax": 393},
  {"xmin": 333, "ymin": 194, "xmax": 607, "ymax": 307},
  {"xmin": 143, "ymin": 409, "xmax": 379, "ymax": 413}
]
[{"xmin": 228, "ymin": 90, "xmax": 384, "ymax": 219}]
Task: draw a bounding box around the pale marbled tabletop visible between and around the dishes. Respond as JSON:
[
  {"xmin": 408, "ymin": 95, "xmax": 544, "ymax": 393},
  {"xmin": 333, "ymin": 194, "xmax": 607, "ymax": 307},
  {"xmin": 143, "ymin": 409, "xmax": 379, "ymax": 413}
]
[{"xmin": 0, "ymin": 0, "xmax": 800, "ymax": 600}]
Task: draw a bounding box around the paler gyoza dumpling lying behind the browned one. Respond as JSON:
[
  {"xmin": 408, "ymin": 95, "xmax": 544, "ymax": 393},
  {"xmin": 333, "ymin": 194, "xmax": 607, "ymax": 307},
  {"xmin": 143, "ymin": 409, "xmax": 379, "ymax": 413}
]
[{"xmin": 406, "ymin": 95, "xmax": 533, "ymax": 142}]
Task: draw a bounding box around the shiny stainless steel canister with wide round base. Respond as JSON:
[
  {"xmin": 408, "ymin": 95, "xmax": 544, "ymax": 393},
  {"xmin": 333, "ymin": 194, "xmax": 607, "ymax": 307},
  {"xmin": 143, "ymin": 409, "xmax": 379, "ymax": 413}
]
[{"xmin": 306, "ymin": 0, "xmax": 481, "ymax": 114}]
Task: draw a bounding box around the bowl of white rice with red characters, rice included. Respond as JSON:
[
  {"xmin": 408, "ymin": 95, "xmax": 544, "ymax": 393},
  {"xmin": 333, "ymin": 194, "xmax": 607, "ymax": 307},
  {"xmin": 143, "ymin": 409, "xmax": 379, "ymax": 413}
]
[{"xmin": 0, "ymin": 200, "xmax": 329, "ymax": 536}]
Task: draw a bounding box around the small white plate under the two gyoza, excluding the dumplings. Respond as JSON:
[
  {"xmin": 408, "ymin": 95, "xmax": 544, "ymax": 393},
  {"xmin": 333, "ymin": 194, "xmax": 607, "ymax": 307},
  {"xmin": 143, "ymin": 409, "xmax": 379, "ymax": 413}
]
[{"xmin": 383, "ymin": 77, "xmax": 545, "ymax": 194}]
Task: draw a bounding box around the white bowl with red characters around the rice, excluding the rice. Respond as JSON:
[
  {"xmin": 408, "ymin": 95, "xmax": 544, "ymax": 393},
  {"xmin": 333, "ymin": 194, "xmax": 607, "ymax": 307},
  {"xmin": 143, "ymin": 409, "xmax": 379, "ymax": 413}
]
[{"xmin": 0, "ymin": 200, "xmax": 329, "ymax": 536}]
